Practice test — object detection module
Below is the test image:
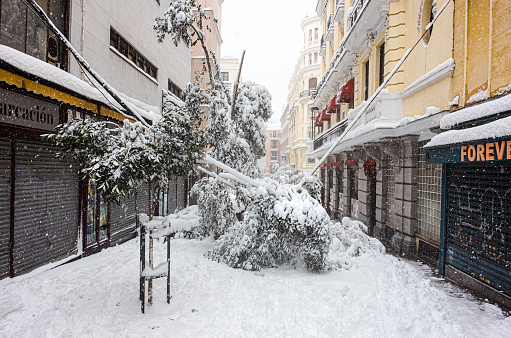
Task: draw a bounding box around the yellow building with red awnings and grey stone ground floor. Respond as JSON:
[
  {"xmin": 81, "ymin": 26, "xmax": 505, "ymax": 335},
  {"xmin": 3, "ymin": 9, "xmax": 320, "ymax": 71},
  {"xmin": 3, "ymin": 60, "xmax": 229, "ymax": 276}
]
[{"xmin": 306, "ymin": 0, "xmax": 457, "ymax": 261}]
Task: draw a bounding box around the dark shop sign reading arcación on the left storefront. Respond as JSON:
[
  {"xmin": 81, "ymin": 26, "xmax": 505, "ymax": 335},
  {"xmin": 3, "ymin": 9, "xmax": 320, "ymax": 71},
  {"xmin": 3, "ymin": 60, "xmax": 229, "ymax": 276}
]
[{"xmin": 0, "ymin": 88, "xmax": 60, "ymax": 130}]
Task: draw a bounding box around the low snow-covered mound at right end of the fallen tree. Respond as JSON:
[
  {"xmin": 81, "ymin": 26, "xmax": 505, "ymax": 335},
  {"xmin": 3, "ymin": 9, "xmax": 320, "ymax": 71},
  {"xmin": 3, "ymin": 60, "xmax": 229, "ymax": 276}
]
[{"xmin": 328, "ymin": 217, "xmax": 385, "ymax": 269}]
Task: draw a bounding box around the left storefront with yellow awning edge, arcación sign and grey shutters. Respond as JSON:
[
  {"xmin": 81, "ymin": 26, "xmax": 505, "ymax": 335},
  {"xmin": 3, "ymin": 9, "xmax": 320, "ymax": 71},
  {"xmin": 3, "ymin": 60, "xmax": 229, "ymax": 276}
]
[{"xmin": 0, "ymin": 70, "xmax": 150, "ymax": 279}]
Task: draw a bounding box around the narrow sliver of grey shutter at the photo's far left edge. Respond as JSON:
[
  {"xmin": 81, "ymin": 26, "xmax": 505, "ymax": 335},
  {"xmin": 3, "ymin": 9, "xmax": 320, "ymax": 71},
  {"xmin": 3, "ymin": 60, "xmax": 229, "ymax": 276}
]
[{"xmin": 0, "ymin": 138, "xmax": 12, "ymax": 279}]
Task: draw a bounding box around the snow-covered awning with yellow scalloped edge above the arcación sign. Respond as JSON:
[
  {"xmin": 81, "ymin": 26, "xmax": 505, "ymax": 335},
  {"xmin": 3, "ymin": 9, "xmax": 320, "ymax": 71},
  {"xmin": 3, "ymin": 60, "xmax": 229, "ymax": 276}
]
[{"xmin": 0, "ymin": 44, "xmax": 161, "ymax": 122}]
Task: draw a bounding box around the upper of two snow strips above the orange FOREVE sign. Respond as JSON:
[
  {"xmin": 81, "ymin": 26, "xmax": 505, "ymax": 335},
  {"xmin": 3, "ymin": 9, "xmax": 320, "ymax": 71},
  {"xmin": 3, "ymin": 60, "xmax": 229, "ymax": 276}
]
[{"xmin": 440, "ymin": 95, "xmax": 511, "ymax": 129}]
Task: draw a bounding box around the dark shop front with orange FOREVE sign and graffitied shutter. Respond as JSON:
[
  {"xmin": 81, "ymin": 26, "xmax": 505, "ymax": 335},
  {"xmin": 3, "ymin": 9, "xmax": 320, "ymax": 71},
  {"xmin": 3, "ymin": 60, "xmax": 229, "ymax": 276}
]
[{"xmin": 427, "ymin": 136, "xmax": 511, "ymax": 303}]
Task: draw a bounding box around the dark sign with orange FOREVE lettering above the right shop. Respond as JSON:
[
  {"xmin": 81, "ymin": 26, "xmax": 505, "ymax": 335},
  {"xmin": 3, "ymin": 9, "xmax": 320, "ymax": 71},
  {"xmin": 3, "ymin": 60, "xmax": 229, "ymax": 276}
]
[{"xmin": 427, "ymin": 139, "xmax": 511, "ymax": 163}]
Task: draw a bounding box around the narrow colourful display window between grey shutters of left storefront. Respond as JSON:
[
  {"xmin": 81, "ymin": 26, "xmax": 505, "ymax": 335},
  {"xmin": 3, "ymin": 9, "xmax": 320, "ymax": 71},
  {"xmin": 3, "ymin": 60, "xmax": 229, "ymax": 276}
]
[{"xmin": 85, "ymin": 183, "xmax": 110, "ymax": 248}]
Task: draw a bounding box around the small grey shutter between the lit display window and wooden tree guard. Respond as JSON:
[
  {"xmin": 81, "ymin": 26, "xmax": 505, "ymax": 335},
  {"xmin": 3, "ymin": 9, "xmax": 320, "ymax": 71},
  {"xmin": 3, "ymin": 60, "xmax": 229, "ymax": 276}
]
[{"xmin": 110, "ymin": 196, "xmax": 136, "ymax": 242}]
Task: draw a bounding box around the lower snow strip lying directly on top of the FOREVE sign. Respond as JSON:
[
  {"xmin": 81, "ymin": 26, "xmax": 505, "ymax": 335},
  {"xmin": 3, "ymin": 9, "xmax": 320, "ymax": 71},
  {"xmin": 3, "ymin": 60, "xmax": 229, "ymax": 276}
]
[{"xmin": 424, "ymin": 117, "xmax": 511, "ymax": 148}]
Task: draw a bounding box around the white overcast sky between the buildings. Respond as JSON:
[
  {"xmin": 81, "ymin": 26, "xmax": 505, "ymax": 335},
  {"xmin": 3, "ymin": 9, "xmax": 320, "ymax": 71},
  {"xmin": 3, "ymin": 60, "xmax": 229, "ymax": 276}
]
[{"xmin": 221, "ymin": 0, "xmax": 317, "ymax": 121}]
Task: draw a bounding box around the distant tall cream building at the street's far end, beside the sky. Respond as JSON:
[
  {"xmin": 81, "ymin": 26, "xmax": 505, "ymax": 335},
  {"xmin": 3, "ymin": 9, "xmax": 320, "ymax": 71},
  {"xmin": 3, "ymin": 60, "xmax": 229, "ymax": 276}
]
[{"xmin": 281, "ymin": 16, "xmax": 321, "ymax": 171}]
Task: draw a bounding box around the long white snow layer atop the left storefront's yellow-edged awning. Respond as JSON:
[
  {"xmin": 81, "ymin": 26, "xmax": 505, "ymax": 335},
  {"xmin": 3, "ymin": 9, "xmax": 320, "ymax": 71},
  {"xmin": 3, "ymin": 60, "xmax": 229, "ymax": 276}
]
[{"xmin": 0, "ymin": 44, "xmax": 161, "ymax": 121}]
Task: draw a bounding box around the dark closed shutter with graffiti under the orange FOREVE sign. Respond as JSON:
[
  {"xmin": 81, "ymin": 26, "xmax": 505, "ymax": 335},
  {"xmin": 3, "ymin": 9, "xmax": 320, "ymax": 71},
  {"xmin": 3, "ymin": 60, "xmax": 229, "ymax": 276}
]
[{"xmin": 446, "ymin": 162, "xmax": 511, "ymax": 295}]
